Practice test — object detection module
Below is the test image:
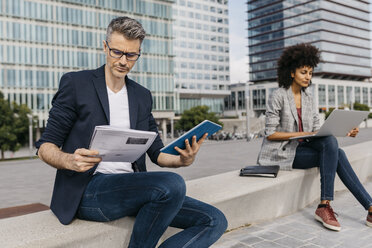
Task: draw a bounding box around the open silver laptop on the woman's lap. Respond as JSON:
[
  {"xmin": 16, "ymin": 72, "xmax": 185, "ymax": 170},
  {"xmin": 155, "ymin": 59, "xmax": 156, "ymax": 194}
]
[{"xmin": 289, "ymin": 109, "xmax": 369, "ymax": 140}]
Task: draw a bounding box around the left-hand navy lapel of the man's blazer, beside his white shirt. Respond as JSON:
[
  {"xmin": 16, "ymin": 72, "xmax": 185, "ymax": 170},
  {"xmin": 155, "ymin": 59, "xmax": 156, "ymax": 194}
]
[{"xmin": 93, "ymin": 66, "xmax": 110, "ymax": 123}]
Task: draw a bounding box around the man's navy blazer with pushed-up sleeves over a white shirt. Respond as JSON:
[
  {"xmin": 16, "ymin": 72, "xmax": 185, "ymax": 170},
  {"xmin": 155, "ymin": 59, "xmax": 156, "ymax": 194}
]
[{"xmin": 36, "ymin": 66, "xmax": 164, "ymax": 225}]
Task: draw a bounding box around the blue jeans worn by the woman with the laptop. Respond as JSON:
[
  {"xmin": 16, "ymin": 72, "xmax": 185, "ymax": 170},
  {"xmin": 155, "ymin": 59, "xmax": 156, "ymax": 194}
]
[{"xmin": 292, "ymin": 136, "xmax": 372, "ymax": 210}]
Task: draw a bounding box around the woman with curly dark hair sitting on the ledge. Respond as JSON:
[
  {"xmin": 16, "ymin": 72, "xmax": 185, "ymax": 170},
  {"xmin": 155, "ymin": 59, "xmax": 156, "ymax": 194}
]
[{"xmin": 258, "ymin": 44, "xmax": 372, "ymax": 231}]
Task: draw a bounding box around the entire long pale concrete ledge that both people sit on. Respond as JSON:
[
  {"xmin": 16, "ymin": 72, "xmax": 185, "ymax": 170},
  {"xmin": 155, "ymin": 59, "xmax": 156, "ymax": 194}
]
[{"xmin": 0, "ymin": 141, "xmax": 372, "ymax": 247}]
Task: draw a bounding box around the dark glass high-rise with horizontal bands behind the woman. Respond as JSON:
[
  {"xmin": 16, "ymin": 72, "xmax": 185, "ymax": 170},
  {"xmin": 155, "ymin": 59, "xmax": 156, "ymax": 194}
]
[{"xmin": 247, "ymin": 0, "xmax": 372, "ymax": 113}]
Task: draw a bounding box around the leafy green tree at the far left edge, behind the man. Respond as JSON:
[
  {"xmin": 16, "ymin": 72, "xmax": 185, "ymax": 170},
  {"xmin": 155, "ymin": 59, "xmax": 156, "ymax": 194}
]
[{"xmin": 0, "ymin": 92, "xmax": 31, "ymax": 160}]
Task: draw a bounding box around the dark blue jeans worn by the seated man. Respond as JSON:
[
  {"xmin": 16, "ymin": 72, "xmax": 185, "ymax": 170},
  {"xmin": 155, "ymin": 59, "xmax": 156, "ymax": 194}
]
[{"xmin": 77, "ymin": 172, "xmax": 227, "ymax": 248}]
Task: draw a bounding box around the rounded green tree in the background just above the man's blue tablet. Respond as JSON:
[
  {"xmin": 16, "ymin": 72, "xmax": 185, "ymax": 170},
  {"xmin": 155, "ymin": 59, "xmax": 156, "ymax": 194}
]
[{"xmin": 175, "ymin": 106, "xmax": 223, "ymax": 131}]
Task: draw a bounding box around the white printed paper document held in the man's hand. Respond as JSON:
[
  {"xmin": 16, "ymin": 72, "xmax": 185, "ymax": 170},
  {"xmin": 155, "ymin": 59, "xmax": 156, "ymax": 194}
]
[{"xmin": 89, "ymin": 125, "xmax": 157, "ymax": 163}]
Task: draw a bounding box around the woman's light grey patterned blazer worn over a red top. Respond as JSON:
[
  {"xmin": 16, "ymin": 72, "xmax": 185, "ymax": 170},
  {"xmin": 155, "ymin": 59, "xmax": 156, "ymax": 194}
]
[{"xmin": 257, "ymin": 87, "xmax": 319, "ymax": 170}]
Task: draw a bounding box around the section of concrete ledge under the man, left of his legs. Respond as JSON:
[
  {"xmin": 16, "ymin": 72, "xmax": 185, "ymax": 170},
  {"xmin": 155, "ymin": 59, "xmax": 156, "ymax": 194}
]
[{"xmin": 0, "ymin": 210, "xmax": 134, "ymax": 248}]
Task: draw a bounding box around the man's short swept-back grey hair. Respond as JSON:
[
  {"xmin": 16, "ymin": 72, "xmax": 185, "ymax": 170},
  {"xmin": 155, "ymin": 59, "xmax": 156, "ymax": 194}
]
[{"xmin": 106, "ymin": 16, "xmax": 146, "ymax": 43}]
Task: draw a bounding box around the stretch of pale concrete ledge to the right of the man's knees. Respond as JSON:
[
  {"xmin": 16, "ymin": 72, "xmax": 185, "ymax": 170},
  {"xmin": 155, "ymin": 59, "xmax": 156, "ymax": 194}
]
[{"xmin": 187, "ymin": 141, "xmax": 372, "ymax": 229}]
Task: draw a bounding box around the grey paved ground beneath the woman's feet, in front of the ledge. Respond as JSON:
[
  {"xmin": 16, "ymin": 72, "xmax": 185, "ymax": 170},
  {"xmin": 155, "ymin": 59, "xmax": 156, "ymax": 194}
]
[{"xmin": 212, "ymin": 180, "xmax": 372, "ymax": 248}]
